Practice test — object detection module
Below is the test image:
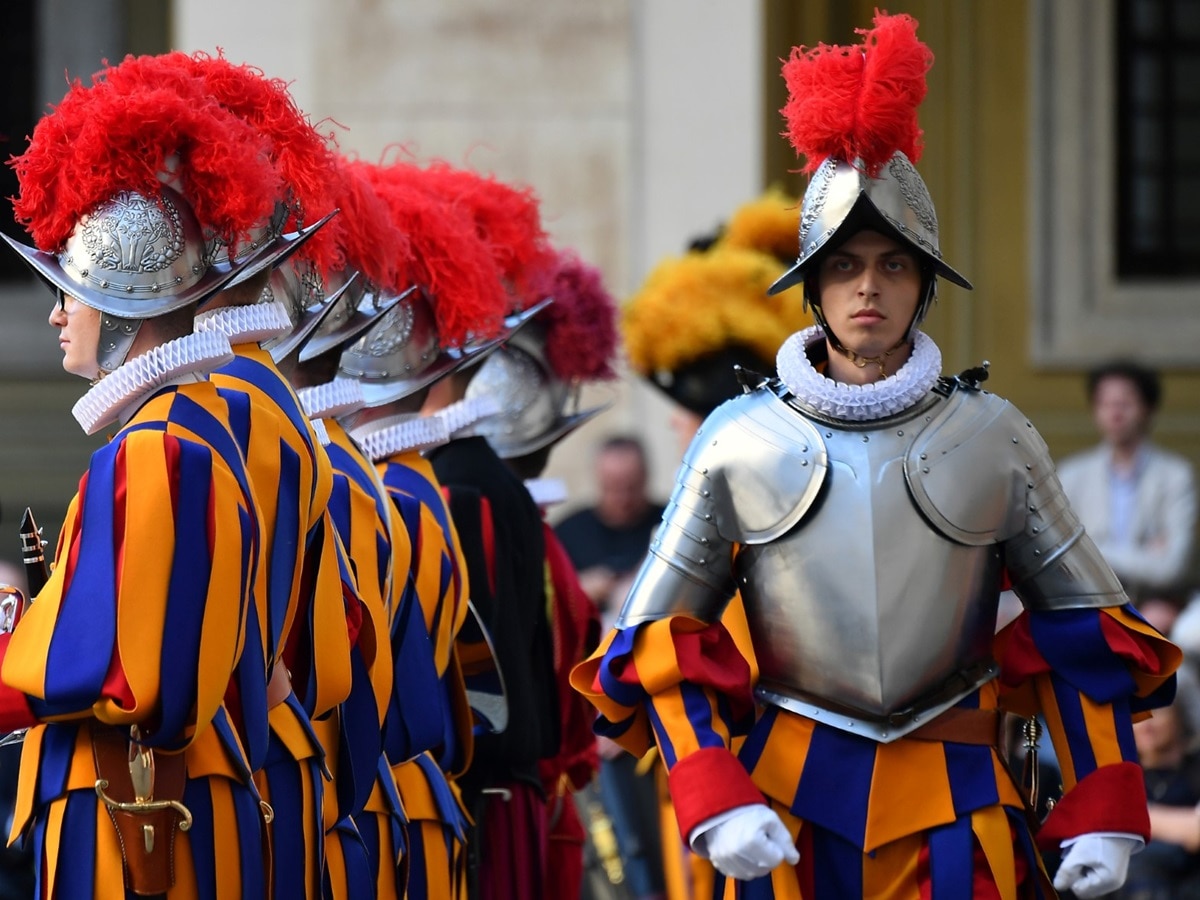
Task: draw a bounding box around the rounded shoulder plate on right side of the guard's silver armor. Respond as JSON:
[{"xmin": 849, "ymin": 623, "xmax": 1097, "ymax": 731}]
[{"xmin": 905, "ymin": 390, "xmax": 1050, "ymax": 546}]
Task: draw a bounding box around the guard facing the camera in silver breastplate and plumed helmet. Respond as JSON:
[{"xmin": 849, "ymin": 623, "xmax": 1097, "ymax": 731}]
[{"xmin": 572, "ymin": 14, "xmax": 1180, "ymax": 900}]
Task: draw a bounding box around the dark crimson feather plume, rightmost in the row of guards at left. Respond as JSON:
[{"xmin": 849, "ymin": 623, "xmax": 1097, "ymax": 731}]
[{"xmin": 535, "ymin": 250, "xmax": 619, "ymax": 382}]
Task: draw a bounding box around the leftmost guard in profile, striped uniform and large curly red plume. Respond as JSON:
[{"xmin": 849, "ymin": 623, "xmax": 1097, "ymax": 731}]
[{"xmin": 0, "ymin": 58, "xmax": 280, "ymax": 900}]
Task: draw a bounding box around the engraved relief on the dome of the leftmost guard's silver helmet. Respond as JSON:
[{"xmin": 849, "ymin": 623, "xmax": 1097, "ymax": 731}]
[{"xmin": 76, "ymin": 191, "xmax": 184, "ymax": 276}]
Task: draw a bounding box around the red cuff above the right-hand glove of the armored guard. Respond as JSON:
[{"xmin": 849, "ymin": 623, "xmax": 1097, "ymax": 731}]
[{"xmin": 1038, "ymin": 762, "xmax": 1150, "ymax": 850}]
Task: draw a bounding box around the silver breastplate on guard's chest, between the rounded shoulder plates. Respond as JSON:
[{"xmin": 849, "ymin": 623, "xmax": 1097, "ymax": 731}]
[{"xmin": 734, "ymin": 398, "xmax": 1002, "ymax": 739}]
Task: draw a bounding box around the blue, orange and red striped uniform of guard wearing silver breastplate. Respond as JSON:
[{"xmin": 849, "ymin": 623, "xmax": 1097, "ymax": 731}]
[{"xmin": 572, "ymin": 595, "xmax": 1178, "ymax": 900}]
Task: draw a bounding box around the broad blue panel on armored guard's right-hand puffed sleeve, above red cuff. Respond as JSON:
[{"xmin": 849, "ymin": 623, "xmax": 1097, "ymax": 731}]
[{"xmin": 1030, "ymin": 607, "xmax": 1136, "ymax": 703}]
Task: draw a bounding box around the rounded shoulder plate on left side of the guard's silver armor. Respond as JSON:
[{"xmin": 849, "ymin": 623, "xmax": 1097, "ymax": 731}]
[{"xmin": 680, "ymin": 388, "xmax": 828, "ymax": 544}]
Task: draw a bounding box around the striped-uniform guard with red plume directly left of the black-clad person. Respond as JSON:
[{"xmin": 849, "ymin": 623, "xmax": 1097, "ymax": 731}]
[{"xmin": 341, "ymin": 163, "xmax": 505, "ymax": 900}]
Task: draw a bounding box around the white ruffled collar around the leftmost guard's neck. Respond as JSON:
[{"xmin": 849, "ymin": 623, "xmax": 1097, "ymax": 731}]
[{"xmin": 71, "ymin": 331, "xmax": 234, "ymax": 434}]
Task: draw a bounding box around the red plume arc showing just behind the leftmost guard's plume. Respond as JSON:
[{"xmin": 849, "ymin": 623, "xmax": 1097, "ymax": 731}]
[{"xmin": 97, "ymin": 50, "xmax": 344, "ymax": 271}]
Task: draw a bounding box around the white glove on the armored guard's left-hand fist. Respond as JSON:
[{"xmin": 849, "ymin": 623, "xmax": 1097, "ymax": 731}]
[{"xmin": 691, "ymin": 803, "xmax": 800, "ymax": 881}]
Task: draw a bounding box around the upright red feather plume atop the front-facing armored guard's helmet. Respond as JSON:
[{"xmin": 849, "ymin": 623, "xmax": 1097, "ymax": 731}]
[{"xmin": 781, "ymin": 12, "xmax": 934, "ymax": 178}]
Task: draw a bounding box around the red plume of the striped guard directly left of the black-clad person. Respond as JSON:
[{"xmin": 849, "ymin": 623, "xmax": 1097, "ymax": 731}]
[{"xmin": 352, "ymin": 162, "xmax": 509, "ymax": 346}]
